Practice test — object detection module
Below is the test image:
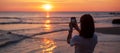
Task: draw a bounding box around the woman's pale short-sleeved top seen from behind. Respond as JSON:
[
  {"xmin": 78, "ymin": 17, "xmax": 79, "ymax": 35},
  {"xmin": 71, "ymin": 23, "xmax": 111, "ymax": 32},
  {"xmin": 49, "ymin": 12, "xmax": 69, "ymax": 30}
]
[{"xmin": 70, "ymin": 35, "xmax": 97, "ymax": 53}]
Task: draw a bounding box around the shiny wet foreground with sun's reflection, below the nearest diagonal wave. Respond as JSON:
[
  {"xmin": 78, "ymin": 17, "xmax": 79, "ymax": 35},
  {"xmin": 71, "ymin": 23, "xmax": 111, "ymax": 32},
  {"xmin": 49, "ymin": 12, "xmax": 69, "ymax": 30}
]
[{"xmin": 0, "ymin": 31, "xmax": 120, "ymax": 53}]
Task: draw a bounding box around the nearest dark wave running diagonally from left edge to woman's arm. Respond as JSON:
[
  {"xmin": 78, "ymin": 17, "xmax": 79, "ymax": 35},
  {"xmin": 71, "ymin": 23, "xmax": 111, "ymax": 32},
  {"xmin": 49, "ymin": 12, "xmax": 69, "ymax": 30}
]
[{"xmin": 0, "ymin": 29, "xmax": 68, "ymax": 47}]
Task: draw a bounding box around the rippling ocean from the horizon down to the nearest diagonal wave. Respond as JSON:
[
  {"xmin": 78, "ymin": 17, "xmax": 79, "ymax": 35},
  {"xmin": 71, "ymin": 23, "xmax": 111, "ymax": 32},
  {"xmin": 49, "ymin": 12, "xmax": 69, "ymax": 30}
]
[{"xmin": 0, "ymin": 12, "xmax": 120, "ymax": 33}]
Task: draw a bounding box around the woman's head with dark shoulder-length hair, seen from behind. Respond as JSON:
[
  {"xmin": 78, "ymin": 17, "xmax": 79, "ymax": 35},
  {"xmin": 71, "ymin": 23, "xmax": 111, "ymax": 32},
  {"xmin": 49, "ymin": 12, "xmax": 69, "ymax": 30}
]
[{"xmin": 80, "ymin": 14, "xmax": 95, "ymax": 38}]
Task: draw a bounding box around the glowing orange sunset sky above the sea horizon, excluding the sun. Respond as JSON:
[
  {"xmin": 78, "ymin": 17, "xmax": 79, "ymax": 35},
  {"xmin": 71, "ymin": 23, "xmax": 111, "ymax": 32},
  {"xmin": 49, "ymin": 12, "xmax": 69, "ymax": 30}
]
[{"xmin": 0, "ymin": 0, "xmax": 120, "ymax": 11}]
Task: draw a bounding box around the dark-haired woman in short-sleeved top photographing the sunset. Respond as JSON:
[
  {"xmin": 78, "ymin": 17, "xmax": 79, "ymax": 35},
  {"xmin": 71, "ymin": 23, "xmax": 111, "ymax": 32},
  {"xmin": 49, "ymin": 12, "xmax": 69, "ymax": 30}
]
[{"xmin": 67, "ymin": 14, "xmax": 97, "ymax": 53}]
